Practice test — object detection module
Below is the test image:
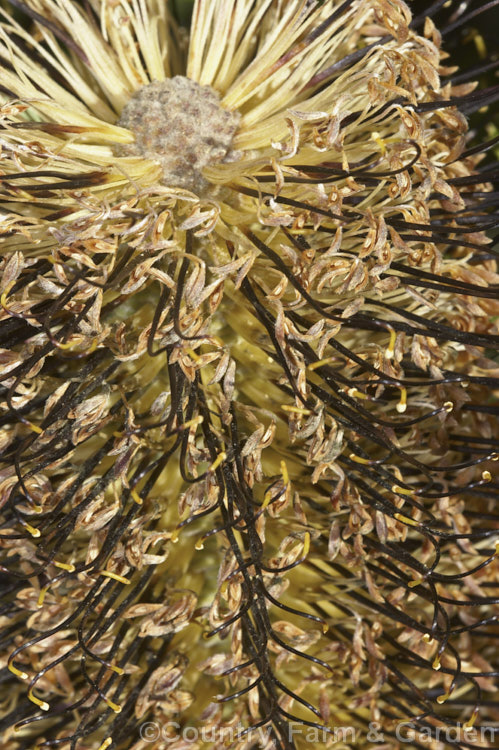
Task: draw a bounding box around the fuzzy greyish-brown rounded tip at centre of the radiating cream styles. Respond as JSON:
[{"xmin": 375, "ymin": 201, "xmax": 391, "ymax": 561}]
[{"xmin": 118, "ymin": 76, "xmax": 239, "ymax": 195}]
